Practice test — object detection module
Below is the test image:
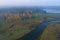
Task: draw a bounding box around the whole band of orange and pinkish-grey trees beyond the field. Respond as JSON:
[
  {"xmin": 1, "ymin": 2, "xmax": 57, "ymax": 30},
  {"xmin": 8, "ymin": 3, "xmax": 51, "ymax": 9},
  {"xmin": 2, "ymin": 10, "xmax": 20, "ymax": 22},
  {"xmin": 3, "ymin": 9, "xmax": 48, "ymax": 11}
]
[{"xmin": 6, "ymin": 11, "xmax": 32, "ymax": 22}]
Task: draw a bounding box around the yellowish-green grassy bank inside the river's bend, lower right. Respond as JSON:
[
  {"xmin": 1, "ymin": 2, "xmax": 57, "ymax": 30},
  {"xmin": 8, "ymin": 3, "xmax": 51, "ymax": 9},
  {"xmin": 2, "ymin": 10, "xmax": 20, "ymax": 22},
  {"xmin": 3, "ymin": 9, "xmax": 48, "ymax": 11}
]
[{"xmin": 38, "ymin": 24, "xmax": 60, "ymax": 40}]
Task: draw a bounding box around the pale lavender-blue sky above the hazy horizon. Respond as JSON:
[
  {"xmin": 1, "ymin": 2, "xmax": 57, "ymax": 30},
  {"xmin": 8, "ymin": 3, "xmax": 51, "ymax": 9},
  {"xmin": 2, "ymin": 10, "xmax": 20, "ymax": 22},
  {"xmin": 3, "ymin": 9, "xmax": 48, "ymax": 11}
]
[{"xmin": 0, "ymin": 0, "xmax": 60, "ymax": 6}]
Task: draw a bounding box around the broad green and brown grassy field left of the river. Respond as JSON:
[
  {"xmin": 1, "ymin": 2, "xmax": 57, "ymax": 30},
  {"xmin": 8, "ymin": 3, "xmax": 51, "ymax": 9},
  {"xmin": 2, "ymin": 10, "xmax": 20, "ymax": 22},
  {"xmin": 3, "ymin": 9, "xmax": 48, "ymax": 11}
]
[{"xmin": 0, "ymin": 13, "xmax": 43, "ymax": 40}]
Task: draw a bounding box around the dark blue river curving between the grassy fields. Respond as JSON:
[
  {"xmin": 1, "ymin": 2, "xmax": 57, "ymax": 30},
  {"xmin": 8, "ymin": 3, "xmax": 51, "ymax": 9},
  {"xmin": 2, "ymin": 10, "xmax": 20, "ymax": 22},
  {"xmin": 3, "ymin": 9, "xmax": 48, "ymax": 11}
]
[{"xmin": 17, "ymin": 20, "xmax": 60, "ymax": 40}]
